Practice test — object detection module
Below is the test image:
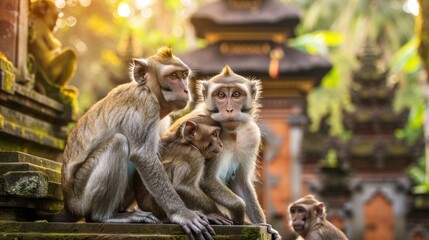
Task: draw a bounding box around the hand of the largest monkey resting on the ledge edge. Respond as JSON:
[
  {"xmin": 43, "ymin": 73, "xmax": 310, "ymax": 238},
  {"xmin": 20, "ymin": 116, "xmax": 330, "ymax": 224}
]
[{"xmin": 170, "ymin": 209, "xmax": 216, "ymax": 240}]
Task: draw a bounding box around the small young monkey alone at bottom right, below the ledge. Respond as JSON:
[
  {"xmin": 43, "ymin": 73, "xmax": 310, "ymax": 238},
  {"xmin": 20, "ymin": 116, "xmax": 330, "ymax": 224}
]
[{"xmin": 289, "ymin": 195, "xmax": 348, "ymax": 240}]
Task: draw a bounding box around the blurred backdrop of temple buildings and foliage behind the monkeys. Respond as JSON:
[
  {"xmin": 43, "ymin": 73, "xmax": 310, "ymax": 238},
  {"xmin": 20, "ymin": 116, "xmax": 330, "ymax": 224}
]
[{"xmin": 45, "ymin": 0, "xmax": 429, "ymax": 240}]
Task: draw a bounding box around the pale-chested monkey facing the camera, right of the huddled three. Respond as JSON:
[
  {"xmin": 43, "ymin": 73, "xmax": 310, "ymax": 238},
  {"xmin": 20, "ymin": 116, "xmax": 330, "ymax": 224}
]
[{"xmin": 169, "ymin": 66, "xmax": 281, "ymax": 239}]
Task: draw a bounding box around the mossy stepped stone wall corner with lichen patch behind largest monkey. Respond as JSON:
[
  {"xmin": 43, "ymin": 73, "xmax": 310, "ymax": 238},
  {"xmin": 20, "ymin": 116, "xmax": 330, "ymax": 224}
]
[{"xmin": 0, "ymin": 152, "xmax": 63, "ymax": 218}]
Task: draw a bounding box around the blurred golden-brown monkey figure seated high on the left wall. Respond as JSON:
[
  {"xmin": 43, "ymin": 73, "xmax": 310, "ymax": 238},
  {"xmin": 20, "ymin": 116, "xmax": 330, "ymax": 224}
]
[{"xmin": 28, "ymin": 0, "xmax": 77, "ymax": 93}]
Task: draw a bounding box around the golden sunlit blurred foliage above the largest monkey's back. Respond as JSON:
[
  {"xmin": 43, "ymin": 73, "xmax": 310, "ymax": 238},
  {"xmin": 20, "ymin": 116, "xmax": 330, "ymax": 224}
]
[{"xmin": 55, "ymin": 0, "xmax": 209, "ymax": 112}]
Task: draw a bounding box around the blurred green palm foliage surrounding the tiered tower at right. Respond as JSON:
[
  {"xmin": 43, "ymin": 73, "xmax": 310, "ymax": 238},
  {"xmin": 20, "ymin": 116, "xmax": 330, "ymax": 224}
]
[{"xmin": 282, "ymin": 0, "xmax": 429, "ymax": 192}]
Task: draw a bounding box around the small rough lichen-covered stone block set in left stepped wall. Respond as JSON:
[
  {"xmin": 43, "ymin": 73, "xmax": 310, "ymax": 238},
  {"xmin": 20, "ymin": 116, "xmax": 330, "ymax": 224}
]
[{"xmin": 3, "ymin": 171, "xmax": 48, "ymax": 198}]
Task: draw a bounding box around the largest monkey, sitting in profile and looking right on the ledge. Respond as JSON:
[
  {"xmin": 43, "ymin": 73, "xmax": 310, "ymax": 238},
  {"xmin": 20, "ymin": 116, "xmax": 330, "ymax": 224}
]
[{"xmin": 56, "ymin": 47, "xmax": 215, "ymax": 239}]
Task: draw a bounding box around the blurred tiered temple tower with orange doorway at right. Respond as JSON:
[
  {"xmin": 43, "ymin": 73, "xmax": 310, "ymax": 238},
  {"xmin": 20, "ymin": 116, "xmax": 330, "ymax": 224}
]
[{"xmin": 303, "ymin": 41, "xmax": 414, "ymax": 240}]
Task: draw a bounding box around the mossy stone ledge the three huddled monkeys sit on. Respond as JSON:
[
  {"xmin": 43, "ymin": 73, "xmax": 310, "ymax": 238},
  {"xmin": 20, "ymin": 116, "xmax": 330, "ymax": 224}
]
[{"xmin": 0, "ymin": 221, "xmax": 271, "ymax": 240}]
